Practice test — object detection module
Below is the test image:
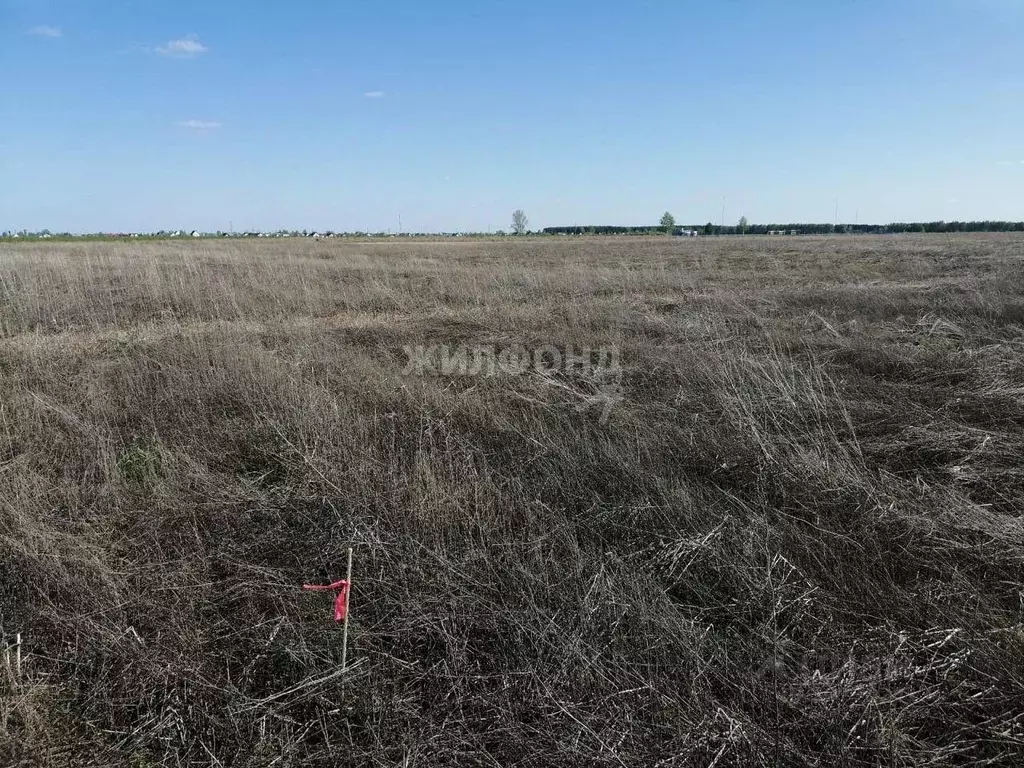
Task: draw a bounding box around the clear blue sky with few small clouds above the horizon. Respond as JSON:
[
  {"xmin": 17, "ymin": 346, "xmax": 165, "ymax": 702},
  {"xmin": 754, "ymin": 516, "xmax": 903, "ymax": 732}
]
[{"xmin": 0, "ymin": 0, "xmax": 1024, "ymax": 231}]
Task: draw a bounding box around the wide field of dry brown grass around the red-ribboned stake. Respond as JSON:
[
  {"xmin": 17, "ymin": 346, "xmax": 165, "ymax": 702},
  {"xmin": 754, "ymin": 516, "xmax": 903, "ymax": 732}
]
[{"xmin": 0, "ymin": 234, "xmax": 1024, "ymax": 768}]
